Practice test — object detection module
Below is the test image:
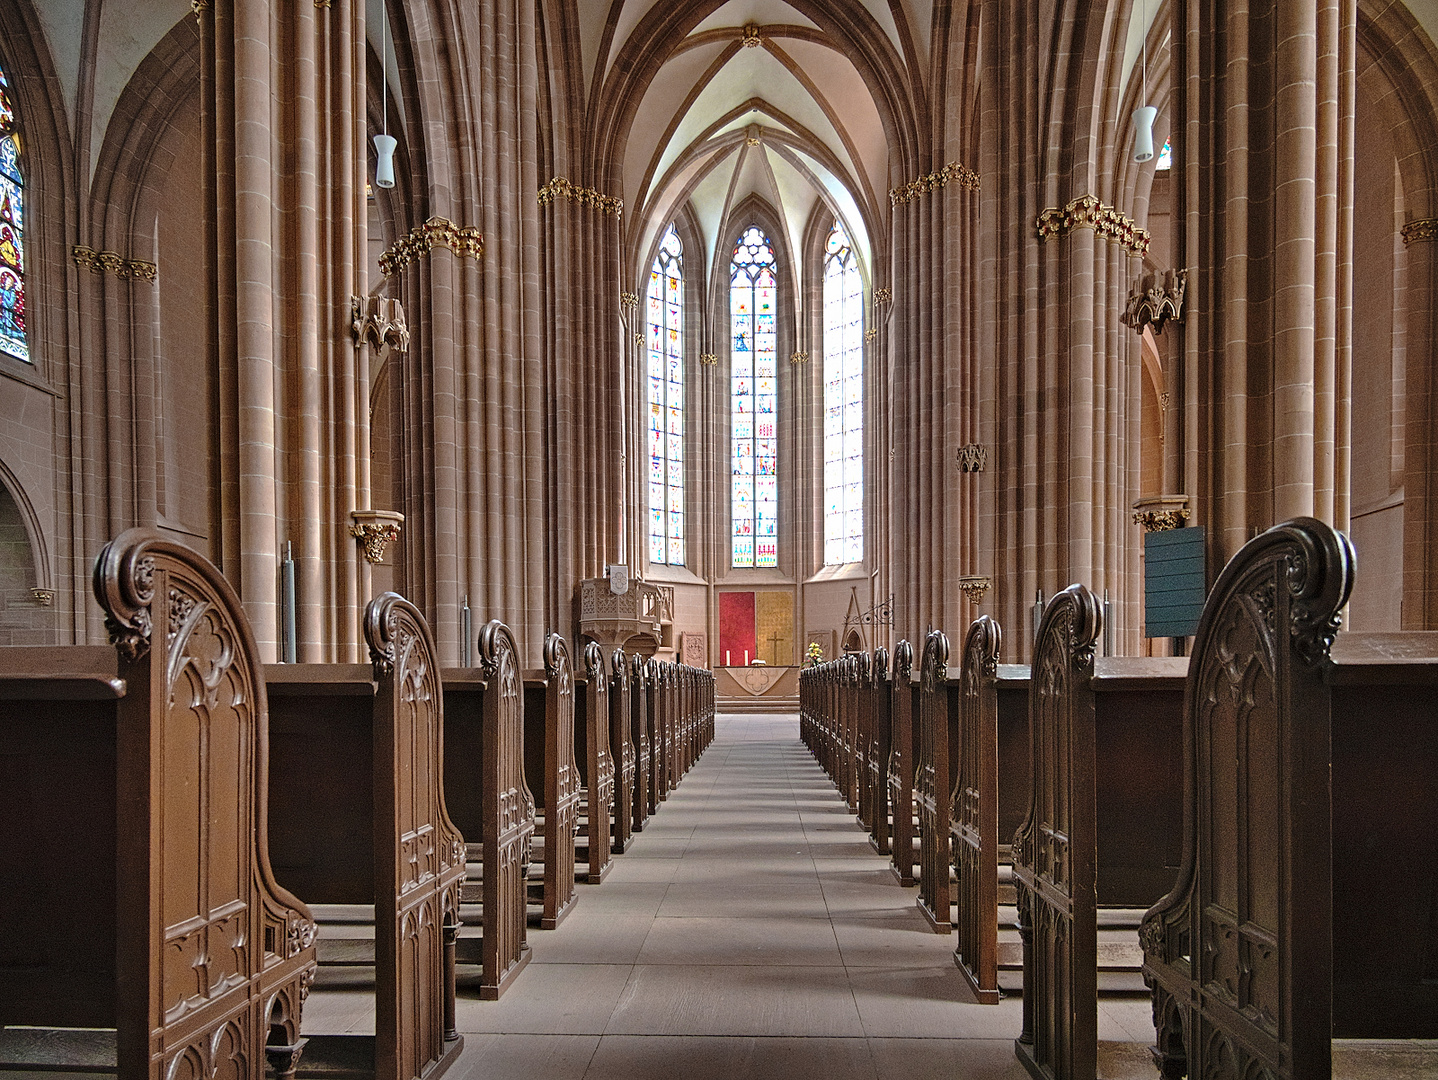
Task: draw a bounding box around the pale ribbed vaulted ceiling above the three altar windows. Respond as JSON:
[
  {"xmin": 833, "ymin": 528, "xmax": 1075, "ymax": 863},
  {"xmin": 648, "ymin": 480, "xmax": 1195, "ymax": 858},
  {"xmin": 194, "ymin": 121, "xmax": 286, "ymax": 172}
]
[{"xmin": 577, "ymin": 0, "xmax": 908, "ymax": 287}]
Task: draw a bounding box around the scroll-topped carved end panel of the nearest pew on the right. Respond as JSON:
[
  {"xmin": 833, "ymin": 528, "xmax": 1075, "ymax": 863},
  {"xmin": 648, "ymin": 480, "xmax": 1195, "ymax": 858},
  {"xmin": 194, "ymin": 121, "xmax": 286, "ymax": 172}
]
[{"xmin": 1140, "ymin": 518, "xmax": 1353, "ymax": 1080}]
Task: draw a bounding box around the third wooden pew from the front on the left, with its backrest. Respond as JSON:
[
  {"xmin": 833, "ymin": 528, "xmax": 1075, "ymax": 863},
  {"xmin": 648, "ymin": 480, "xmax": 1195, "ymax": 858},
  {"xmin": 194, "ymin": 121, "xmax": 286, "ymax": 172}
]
[{"xmin": 441, "ymin": 618, "xmax": 535, "ymax": 1001}]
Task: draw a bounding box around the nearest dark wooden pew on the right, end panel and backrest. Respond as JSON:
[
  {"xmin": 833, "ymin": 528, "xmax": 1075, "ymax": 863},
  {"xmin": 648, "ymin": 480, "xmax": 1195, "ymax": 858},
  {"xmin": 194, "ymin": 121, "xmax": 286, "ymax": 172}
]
[{"xmin": 1140, "ymin": 518, "xmax": 1438, "ymax": 1079}]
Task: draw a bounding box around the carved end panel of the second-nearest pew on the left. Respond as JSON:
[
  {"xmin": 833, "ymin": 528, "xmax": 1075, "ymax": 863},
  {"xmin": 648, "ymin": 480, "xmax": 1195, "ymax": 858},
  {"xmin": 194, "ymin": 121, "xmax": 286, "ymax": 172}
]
[{"xmin": 364, "ymin": 592, "xmax": 464, "ymax": 1080}]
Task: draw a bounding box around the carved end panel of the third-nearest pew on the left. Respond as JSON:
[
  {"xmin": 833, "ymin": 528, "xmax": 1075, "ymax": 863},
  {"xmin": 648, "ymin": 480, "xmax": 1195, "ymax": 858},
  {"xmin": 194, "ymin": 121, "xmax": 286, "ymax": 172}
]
[{"xmin": 479, "ymin": 618, "xmax": 535, "ymax": 998}]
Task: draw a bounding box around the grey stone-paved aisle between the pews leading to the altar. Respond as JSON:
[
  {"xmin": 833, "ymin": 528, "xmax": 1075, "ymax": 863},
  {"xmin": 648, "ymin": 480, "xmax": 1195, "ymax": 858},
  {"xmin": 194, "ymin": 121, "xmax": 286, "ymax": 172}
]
[{"xmin": 450, "ymin": 715, "xmax": 1152, "ymax": 1080}]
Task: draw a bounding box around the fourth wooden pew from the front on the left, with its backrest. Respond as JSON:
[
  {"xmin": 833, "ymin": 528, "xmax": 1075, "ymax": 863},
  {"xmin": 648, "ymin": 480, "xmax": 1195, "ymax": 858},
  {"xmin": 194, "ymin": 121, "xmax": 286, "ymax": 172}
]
[{"xmin": 525, "ymin": 633, "xmax": 580, "ymax": 930}]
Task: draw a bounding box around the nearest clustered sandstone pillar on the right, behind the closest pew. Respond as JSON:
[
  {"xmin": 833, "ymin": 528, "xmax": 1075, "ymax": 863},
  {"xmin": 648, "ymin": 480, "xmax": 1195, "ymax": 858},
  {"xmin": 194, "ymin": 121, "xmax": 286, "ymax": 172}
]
[{"xmin": 1173, "ymin": 0, "xmax": 1356, "ymax": 571}]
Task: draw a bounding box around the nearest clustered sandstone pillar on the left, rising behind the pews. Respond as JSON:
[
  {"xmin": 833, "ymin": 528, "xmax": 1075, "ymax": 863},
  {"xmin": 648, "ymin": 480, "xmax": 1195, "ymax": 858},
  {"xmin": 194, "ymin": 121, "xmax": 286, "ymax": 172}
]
[{"xmin": 197, "ymin": 0, "xmax": 370, "ymax": 662}]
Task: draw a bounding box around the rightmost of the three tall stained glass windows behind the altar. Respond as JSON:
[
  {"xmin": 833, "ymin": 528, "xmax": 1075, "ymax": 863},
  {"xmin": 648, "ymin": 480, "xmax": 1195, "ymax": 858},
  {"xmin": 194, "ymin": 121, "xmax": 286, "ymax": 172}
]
[{"xmin": 824, "ymin": 221, "xmax": 864, "ymax": 567}]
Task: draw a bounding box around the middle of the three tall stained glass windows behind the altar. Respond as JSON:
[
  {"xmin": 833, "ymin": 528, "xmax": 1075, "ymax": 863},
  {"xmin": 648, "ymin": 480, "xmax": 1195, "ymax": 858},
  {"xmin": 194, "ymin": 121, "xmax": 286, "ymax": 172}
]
[{"xmin": 729, "ymin": 224, "xmax": 779, "ymax": 567}]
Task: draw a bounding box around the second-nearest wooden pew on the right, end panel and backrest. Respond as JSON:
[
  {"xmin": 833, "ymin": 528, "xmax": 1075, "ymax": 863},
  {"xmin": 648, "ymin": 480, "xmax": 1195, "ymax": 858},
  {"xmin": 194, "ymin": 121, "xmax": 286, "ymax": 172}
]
[{"xmin": 1001, "ymin": 585, "xmax": 1186, "ymax": 1079}]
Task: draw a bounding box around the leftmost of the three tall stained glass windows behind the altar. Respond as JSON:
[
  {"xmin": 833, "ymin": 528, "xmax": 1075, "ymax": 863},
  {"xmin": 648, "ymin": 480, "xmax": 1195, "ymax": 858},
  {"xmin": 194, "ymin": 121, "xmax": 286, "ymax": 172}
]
[{"xmin": 647, "ymin": 226, "xmax": 684, "ymax": 567}]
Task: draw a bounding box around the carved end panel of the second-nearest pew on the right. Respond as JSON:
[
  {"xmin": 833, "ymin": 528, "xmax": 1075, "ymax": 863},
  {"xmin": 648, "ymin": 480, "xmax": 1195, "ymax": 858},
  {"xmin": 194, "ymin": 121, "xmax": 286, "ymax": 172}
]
[{"xmin": 1014, "ymin": 585, "xmax": 1103, "ymax": 1079}]
